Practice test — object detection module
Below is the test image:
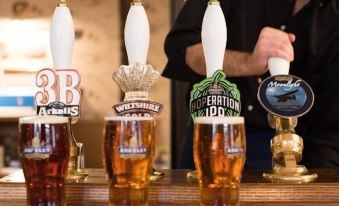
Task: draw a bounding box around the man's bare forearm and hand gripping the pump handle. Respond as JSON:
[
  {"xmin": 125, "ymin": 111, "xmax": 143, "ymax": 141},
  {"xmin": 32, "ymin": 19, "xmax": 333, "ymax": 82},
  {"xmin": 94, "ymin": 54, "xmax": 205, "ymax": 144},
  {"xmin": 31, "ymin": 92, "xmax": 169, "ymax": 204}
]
[{"xmin": 185, "ymin": 27, "xmax": 295, "ymax": 77}]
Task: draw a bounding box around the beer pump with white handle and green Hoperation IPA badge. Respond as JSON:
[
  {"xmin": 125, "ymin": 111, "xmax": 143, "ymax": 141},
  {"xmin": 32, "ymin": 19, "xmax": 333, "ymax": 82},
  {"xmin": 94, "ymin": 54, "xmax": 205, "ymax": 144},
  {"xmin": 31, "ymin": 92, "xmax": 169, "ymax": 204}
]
[{"xmin": 187, "ymin": 0, "xmax": 240, "ymax": 181}]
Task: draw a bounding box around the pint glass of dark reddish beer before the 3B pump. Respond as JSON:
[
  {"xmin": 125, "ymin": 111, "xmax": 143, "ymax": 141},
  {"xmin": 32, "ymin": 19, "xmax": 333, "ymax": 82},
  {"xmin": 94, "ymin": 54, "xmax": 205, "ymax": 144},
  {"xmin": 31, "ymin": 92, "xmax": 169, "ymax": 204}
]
[{"xmin": 19, "ymin": 116, "xmax": 70, "ymax": 206}]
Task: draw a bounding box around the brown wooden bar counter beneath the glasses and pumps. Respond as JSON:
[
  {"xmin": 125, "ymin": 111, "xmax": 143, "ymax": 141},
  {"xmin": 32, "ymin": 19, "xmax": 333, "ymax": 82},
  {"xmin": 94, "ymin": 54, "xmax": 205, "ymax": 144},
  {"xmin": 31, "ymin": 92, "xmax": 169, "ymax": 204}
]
[{"xmin": 0, "ymin": 169, "xmax": 339, "ymax": 206}]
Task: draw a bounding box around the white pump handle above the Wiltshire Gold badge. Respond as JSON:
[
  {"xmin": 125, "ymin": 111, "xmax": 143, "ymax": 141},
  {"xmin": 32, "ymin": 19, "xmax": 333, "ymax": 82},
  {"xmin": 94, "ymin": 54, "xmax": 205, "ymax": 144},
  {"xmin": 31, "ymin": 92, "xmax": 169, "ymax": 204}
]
[{"xmin": 124, "ymin": 0, "xmax": 150, "ymax": 64}]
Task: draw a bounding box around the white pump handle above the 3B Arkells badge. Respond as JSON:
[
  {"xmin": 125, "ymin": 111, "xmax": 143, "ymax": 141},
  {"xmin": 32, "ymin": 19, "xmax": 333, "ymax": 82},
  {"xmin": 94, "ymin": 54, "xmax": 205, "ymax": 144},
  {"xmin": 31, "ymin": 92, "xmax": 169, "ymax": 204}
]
[{"xmin": 50, "ymin": 1, "xmax": 74, "ymax": 69}]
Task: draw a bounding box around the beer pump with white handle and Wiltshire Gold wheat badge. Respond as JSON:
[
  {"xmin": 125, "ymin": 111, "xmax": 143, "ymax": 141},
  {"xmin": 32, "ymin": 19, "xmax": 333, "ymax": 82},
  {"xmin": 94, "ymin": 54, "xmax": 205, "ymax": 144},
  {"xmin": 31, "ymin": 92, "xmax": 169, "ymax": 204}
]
[{"xmin": 113, "ymin": 0, "xmax": 164, "ymax": 180}]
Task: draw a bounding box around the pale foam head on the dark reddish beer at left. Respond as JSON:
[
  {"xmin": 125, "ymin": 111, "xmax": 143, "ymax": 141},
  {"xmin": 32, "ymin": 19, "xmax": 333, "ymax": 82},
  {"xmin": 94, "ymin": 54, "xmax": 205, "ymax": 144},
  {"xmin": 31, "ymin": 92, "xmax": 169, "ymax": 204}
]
[{"xmin": 19, "ymin": 115, "xmax": 69, "ymax": 124}]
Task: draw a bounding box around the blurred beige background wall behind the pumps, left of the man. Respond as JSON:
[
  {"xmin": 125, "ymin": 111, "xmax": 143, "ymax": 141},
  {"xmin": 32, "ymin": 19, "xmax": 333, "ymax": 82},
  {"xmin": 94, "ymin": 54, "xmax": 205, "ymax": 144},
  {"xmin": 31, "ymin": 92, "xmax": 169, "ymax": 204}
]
[{"xmin": 0, "ymin": 0, "xmax": 188, "ymax": 175}]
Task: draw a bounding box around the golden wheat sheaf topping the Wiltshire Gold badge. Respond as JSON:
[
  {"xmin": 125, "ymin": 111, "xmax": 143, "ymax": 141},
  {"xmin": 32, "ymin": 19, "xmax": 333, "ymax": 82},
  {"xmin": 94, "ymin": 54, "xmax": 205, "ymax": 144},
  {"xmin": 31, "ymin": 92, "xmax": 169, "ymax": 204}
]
[{"xmin": 113, "ymin": 63, "xmax": 160, "ymax": 92}]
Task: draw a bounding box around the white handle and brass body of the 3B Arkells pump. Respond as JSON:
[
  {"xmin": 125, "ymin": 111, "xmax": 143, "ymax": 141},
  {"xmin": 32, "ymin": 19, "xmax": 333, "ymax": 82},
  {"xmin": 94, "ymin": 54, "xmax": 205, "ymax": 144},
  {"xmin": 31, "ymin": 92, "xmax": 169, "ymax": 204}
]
[{"xmin": 50, "ymin": 0, "xmax": 88, "ymax": 179}]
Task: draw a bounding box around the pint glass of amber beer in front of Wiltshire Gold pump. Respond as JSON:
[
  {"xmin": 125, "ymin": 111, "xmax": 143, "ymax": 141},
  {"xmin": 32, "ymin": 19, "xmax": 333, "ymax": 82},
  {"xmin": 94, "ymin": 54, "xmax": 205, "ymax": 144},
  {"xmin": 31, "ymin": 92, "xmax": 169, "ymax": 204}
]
[{"xmin": 104, "ymin": 116, "xmax": 155, "ymax": 206}]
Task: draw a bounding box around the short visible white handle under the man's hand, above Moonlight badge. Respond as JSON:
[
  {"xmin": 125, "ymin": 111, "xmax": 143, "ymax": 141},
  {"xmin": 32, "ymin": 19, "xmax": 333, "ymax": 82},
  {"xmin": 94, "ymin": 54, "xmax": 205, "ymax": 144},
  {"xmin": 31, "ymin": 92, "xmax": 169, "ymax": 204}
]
[{"xmin": 267, "ymin": 57, "xmax": 290, "ymax": 76}]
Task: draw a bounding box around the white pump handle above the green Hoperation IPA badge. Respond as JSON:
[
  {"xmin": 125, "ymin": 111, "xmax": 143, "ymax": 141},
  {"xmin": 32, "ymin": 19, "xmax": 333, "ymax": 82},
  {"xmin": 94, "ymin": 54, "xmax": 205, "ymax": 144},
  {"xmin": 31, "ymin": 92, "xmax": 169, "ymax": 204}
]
[{"xmin": 201, "ymin": 0, "xmax": 227, "ymax": 77}]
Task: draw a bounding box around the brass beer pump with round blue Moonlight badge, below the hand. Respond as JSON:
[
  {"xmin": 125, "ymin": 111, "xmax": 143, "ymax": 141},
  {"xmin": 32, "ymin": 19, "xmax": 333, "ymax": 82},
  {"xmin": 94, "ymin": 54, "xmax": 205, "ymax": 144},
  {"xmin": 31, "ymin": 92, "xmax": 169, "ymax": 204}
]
[{"xmin": 258, "ymin": 57, "xmax": 317, "ymax": 183}]
